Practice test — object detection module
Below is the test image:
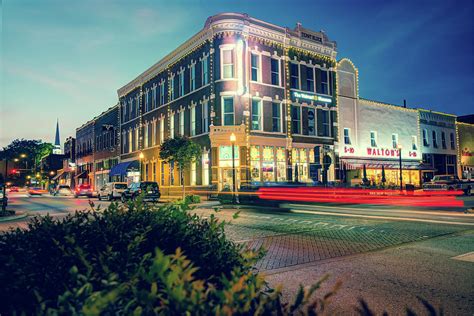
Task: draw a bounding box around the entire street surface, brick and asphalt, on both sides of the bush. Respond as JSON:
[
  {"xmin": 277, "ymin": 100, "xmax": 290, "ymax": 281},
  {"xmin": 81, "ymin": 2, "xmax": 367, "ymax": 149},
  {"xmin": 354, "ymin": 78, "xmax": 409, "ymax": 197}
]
[{"xmin": 0, "ymin": 193, "xmax": 474, "ymax": 315}]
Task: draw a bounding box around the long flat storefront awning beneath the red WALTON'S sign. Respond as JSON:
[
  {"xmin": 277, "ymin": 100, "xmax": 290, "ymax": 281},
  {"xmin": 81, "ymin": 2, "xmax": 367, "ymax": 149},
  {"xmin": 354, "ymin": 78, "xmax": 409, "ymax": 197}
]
[{"xmin": 341, "ymin": 159, "xmax": 433, "ymax": 170}]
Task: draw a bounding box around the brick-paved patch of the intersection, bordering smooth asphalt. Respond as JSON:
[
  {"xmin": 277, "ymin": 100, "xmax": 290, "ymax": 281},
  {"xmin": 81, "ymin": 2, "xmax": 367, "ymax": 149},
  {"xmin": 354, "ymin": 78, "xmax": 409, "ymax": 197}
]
[{"xmin": 226, "ymin": 214, "xmax": 461, "ymax": 271}]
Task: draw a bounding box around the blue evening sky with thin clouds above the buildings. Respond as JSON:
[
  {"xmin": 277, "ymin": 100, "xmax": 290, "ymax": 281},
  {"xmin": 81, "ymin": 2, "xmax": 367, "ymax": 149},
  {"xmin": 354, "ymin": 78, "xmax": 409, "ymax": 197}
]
[{"xmin": 0, "ymin": 0, "xmax": 474, "ymax": 146}]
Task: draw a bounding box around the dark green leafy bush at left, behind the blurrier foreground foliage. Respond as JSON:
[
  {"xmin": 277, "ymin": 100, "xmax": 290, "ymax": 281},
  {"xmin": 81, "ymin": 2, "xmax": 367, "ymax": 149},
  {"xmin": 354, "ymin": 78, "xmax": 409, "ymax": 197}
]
[{"xmin": 0, "ymin": 200, "xmax": 246, "ymax": 314}]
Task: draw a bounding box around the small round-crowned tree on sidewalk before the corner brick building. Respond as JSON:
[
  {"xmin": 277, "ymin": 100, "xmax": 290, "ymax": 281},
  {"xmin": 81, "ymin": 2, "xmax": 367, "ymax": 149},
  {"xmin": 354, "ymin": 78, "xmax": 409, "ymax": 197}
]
[{"xmin": 160, "ymin": 137, "xmax": 202, "ymax": 199}]
